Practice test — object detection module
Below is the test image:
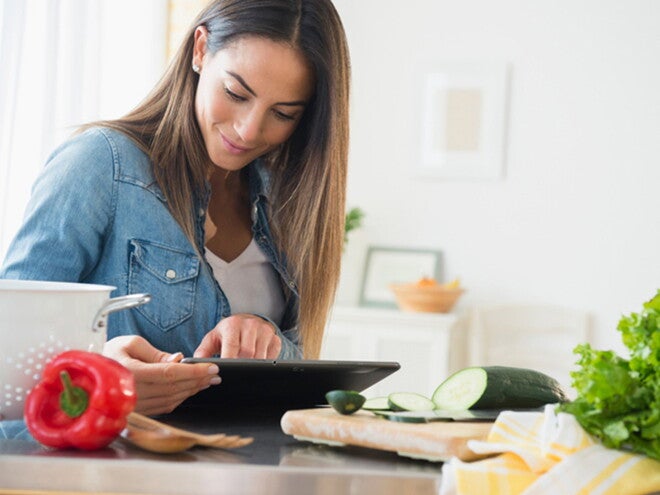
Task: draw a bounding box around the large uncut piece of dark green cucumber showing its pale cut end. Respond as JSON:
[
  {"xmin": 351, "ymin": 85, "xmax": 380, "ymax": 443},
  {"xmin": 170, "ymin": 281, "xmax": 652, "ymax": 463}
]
[{"xmin": 432, "ymin": 366, "xmax": 568, "ymax": 411}]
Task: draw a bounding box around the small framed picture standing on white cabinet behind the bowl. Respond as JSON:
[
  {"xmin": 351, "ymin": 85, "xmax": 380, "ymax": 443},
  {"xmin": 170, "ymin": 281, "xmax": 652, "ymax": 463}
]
[{"xmin": 360, "ymin": 246, "xmax": 442, "ymax": 308}]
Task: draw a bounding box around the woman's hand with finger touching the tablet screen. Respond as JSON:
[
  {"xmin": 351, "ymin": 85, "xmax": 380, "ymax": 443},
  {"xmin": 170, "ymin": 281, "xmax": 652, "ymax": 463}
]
[{"xmin": 194, "ymin": 314, "xmax": 282, "ymax": 359}]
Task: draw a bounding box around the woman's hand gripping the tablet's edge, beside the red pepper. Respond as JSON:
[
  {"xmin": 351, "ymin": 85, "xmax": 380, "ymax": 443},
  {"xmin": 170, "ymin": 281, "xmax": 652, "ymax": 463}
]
[{"xmin": 103, "ymin": 335, "xmax": 220, "ymax": 414}]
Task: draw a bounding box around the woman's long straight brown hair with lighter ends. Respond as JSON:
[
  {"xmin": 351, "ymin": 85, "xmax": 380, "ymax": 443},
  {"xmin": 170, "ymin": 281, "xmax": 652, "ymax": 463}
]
[{"xmin": 92, "ymin": 0, "xmax": 350, "ymax": 358}]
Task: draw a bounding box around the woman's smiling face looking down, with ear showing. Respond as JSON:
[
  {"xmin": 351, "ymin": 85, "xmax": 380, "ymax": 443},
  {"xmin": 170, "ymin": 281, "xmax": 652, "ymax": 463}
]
[{"xmin": 192, "ymin": 27, "xmax": 314, "ymax": 171}]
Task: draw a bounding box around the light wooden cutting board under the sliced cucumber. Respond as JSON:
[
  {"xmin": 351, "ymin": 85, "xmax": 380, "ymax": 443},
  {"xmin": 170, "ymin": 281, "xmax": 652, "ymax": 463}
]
[{"xmin": 280, "ymin": 408, "xmax": 493, "ymax": 461}]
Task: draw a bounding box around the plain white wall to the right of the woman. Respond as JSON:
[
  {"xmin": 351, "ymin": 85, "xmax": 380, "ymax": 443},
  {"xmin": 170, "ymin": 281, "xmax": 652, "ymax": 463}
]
[{"xmin": 335, "ymin": 0, "xmax": 660, "ymax": 351}]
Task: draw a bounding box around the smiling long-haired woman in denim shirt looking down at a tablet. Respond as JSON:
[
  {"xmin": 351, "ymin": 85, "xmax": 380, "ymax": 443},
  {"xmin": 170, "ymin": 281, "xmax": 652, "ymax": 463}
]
[{"xmin": 0, "ymin": 0, "xmax": 349, "ymax": 414}]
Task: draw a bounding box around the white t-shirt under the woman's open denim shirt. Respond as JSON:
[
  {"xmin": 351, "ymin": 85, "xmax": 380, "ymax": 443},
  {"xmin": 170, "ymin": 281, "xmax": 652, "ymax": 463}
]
[{"xmin": 205, "ymin": 239, "xmax": 284, "ymax": 325}]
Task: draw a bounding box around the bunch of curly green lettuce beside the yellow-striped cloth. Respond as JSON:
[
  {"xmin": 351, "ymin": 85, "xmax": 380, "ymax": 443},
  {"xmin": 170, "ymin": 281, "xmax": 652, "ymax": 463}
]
[{"xmin": 559, "ymin": 290, "xmax": 660, "ymax": 460}]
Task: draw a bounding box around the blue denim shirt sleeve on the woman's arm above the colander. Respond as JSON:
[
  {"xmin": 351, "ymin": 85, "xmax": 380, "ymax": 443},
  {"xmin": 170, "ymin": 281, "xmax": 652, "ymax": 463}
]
[{"xmin": 0, "ymin": 130, "xmax": 116, "ymax": 282}]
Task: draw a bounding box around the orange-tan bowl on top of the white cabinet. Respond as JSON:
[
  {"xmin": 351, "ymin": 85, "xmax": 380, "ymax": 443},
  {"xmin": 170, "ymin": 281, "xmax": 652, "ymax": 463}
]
[{"xmin": 390, "ymin": 282, "xmax": 464, "ymax": 313}]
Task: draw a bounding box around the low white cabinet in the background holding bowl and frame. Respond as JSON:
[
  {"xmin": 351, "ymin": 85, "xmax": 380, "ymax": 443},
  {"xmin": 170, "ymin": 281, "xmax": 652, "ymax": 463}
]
[{"xmin": 321, "ymin": 306, "xmax": 466, "ymax": 397}]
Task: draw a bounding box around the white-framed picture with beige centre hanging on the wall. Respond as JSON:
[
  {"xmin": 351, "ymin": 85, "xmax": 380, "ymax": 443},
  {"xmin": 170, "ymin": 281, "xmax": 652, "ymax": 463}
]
[{"xmin": 416, "ymin": 61, "xmax": 509, "ymax": 180}]
